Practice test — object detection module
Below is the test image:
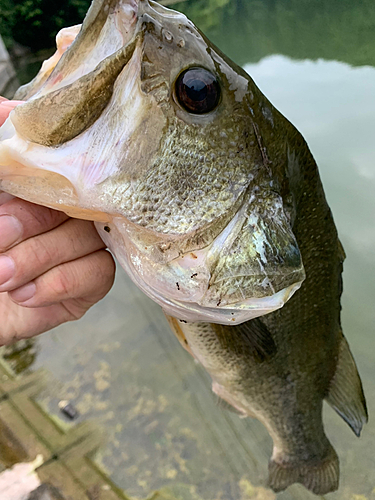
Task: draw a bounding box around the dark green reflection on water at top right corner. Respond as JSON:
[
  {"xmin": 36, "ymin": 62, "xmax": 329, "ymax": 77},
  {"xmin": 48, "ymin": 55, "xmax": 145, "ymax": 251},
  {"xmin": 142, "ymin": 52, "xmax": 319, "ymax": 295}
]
[{"xmin": 184, "ymin": 0, "xmax": 375, "ymax": 66}]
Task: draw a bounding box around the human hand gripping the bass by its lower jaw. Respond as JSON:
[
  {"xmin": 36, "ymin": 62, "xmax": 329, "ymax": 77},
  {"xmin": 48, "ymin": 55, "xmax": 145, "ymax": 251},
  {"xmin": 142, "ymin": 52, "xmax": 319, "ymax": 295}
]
[{"xmin": 0, "ymin": 98, "xmax": 115, "ymax": 345}]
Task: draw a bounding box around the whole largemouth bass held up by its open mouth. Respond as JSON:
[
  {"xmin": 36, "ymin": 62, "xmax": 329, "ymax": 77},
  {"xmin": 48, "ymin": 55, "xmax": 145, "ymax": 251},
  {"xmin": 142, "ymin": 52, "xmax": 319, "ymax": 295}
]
[{"xmin": 0, "ymin": 0, "xmax": 367, "ymax": 494}]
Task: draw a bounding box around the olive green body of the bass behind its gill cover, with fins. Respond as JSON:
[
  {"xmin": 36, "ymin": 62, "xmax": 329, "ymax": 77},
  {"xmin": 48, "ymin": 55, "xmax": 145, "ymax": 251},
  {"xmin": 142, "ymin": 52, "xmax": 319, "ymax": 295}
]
[{"xmin": 170, "ymin": 103, "xmax": 367, "ymax": 495}]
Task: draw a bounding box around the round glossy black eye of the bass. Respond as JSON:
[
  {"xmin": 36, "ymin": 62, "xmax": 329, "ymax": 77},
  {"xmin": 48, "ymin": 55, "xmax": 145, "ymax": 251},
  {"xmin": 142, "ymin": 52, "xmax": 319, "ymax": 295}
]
[{"xmin": 175, "ymin": 67, "xmax": 221, "ymax": 115}]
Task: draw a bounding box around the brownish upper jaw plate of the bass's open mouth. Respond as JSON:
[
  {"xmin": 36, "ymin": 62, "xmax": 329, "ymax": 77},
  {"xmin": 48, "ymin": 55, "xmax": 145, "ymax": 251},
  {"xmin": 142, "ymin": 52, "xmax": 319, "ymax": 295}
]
[{"xmin": 11, "ymin": 0, "xmax": 142, "ymax": 147}]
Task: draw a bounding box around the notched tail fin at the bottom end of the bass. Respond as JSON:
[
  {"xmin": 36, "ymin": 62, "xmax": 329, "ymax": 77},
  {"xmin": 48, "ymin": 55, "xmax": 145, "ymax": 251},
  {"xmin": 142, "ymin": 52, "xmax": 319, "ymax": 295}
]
[{"xmin": 268, "ymin": 446, "xmax": 339, "ymax": 495}]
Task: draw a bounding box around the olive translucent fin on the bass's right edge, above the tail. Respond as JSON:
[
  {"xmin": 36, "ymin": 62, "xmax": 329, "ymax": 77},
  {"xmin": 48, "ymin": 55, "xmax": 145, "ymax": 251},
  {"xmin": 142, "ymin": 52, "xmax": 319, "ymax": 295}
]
[{"xmin": 326, "ymin": 336, "xmax": 368, "ymax": 436}]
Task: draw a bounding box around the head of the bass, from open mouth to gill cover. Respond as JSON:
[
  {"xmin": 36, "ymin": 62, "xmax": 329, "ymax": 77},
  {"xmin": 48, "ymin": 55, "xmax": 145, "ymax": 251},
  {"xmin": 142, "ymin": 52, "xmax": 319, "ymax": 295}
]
[{"xmin": 0, "ymin": 0, "xmax": 305, "ymax": 325}]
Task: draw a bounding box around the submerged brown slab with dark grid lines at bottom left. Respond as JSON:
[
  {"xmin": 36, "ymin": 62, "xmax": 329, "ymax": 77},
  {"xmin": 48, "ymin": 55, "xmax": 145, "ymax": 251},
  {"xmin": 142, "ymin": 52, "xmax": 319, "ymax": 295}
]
[{"xmin": 0, "ymin": 362, "xmax": 126, "ymax": 500}]
